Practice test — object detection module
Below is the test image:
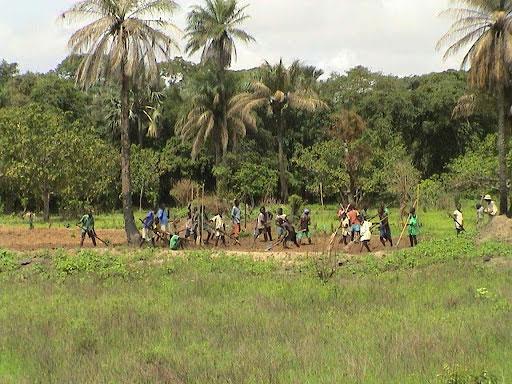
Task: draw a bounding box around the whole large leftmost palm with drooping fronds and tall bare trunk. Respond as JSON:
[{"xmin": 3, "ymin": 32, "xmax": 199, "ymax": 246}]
[{"xmin": 61, "ymin": 0, "xmax": 178, "ymax": 243}]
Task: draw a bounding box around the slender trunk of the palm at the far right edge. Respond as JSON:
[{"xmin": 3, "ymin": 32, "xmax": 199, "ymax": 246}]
[{"xmin": 496, "ymin": 86, "xmax": 508, "ymax": 215}]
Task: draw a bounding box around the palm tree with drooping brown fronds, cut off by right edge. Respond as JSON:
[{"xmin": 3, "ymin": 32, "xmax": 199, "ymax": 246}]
[{"xmin": 438, "ymin": 0, "xmax": 512, "ymax": 214}]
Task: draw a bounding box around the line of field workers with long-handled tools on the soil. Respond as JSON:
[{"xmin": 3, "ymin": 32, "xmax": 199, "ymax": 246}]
[{"xmin": 77, "ymin": 195, "xmax": 498, "ymax": 252}]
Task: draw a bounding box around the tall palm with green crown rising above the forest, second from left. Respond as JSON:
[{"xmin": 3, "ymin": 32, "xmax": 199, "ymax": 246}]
[{"xmin": 186, "ymin": 0, "xmax": 254, "ymax": 164}]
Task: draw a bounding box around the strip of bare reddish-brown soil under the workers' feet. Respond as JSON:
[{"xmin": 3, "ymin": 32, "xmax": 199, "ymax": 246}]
[{"xmin": 0, "ymin": 226, "xmax": 409, "ymax": 258}]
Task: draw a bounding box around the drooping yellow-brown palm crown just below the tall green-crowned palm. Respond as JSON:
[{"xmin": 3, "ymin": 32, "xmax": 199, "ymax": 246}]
[{"xmin": 175, "ymin": 71, "xmax": 257, "ymax": 160}]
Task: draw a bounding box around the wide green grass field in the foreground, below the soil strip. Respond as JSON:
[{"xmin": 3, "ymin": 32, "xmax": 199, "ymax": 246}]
[{"xmin": 0, "ymin": 238, "xmax": 512, "ymax": 383}]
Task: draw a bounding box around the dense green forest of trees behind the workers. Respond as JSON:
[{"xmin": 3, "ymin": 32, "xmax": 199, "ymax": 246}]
[{"xmin": 0, "ymin": 57, "xmax": 497, "ymax": 219}]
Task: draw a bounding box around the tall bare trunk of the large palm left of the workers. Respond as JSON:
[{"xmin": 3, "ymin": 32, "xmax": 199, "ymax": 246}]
[{"xmin": 121, "ymin": 62, "xmax": 140, "ymax": 244}]
